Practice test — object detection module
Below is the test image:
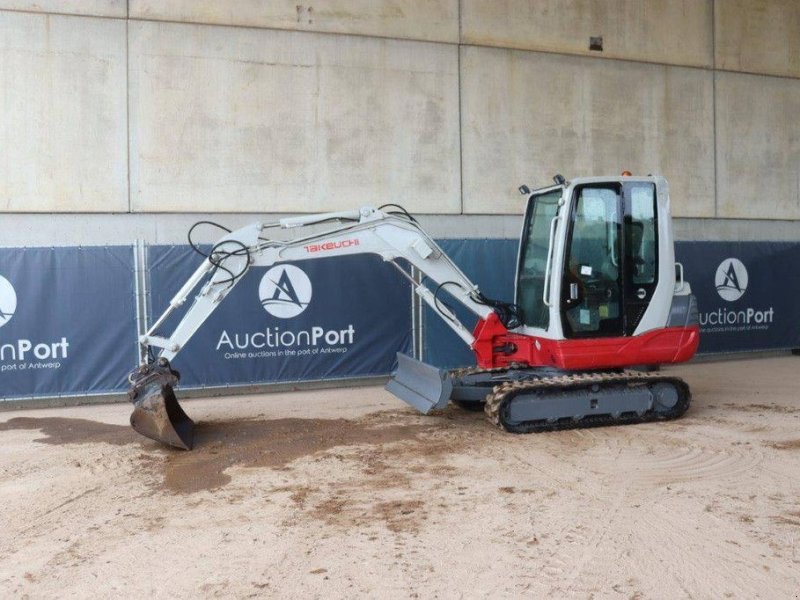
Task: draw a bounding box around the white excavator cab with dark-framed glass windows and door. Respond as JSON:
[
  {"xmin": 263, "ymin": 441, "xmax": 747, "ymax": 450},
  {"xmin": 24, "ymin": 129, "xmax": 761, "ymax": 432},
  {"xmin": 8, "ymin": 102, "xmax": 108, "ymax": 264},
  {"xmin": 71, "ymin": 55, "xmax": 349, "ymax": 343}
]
[{"xmin": 515, "ymin": 177, "xmax": 676, "ymax": 350}]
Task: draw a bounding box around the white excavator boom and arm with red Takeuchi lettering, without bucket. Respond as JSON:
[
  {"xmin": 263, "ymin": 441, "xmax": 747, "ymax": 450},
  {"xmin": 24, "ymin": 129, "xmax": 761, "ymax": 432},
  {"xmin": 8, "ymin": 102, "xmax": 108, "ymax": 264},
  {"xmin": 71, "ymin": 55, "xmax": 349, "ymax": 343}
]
[{"xmin": 140, "ymin": 207, "xmax": 506, "ymax": 361}]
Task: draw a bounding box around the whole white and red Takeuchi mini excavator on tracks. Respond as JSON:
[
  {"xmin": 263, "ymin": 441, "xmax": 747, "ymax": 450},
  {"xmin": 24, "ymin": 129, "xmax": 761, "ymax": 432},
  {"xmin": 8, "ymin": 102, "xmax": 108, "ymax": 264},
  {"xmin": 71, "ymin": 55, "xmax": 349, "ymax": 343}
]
[{"xmin": 129, "ymin": 173, "xmax": 699, "ymax": 449}]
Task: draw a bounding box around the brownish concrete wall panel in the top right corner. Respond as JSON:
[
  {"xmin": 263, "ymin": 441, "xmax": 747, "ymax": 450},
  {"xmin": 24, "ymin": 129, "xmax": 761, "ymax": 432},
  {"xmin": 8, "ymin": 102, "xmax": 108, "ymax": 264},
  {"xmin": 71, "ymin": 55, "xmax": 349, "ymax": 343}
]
[{"xmin": 714, "ymin": 0, "xmax": 800, "ymax": 77}]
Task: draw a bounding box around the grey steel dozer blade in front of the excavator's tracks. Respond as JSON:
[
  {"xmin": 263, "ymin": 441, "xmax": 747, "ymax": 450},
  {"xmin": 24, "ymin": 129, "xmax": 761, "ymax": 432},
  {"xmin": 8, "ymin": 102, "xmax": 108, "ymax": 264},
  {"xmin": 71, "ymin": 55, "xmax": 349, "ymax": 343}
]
[{"xmin": 386, "ymin": 352, "xmax": 453, "ymax": 415}]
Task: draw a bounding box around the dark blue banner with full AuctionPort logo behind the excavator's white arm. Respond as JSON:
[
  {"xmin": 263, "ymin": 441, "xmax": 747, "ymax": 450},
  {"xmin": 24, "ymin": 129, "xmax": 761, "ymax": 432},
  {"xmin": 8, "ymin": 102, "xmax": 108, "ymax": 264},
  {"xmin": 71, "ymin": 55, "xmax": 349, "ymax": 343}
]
[{"xmin": 148, "ymin": 246, "xmax": 412, "ymax": 386}]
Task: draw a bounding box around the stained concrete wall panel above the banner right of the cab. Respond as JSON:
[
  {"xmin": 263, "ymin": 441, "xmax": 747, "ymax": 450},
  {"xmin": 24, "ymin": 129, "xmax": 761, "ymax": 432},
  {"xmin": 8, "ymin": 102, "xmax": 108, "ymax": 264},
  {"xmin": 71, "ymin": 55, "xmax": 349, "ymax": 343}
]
[{"xmin": 716, "ymin": 73, "xmax": 800, "ymax": 219}]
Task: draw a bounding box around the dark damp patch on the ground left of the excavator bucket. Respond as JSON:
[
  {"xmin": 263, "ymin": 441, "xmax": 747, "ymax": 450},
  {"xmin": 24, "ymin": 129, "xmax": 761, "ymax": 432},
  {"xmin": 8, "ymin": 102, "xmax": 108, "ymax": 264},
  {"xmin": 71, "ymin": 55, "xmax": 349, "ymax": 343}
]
[{"xmin": 0, "ymin": 417, "xmax": 142, "ymax": 446}]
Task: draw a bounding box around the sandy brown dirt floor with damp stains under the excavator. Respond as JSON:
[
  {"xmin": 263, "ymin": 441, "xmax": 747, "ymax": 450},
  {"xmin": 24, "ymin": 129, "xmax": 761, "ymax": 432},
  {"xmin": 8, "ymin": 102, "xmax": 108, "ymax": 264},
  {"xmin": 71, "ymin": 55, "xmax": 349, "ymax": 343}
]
[{"xmin": 0, "ymin": 356, "xmax": 800, "ymax": 599}]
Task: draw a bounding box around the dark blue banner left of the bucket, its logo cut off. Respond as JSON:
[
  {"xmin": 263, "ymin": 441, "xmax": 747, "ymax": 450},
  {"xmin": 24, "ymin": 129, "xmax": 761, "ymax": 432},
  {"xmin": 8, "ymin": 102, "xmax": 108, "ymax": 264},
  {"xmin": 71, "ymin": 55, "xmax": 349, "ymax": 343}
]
[{"xmin": 0, "ymin": 246, "xmax": 137, "ymax": 399}]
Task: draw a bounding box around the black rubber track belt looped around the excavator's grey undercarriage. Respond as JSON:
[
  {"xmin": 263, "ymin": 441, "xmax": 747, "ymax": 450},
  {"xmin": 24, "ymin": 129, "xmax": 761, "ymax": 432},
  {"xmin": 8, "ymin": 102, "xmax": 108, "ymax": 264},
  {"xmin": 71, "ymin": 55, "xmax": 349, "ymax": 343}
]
[{"xmin": 484, "ymin": 371, "xmax": 692, "ymax": 433}]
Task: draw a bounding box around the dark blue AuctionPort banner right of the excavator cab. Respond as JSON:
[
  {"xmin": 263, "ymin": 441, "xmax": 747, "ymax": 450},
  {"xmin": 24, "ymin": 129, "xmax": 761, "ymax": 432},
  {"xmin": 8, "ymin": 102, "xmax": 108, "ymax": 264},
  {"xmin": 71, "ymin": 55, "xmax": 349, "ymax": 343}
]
[{"xmin": 675, "ymin": 242, "xmax": 800, "ymax": 353}]
